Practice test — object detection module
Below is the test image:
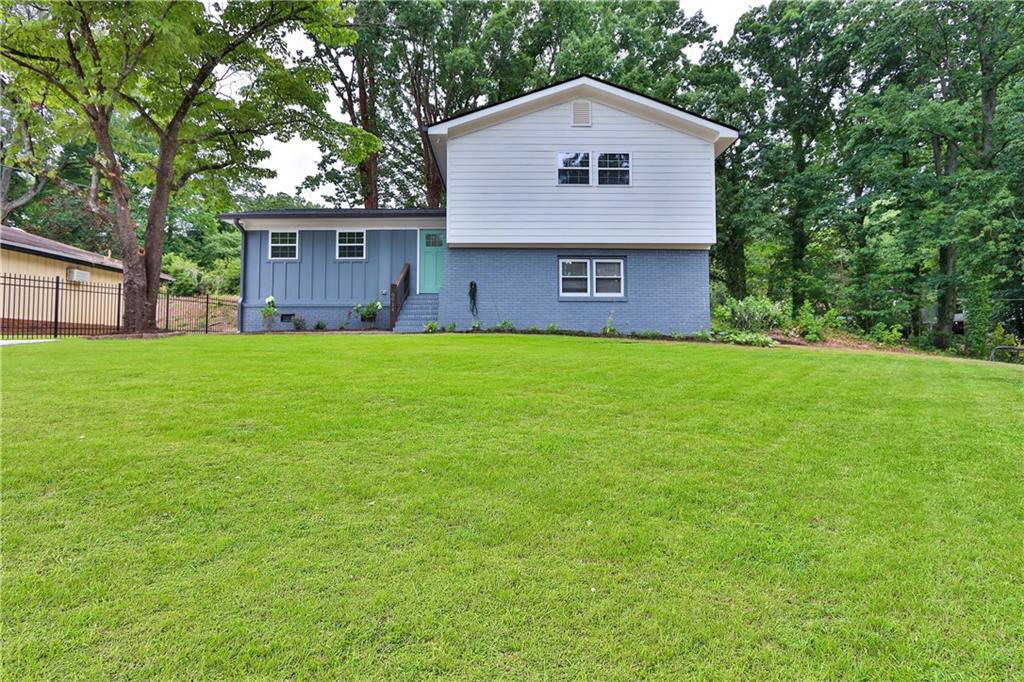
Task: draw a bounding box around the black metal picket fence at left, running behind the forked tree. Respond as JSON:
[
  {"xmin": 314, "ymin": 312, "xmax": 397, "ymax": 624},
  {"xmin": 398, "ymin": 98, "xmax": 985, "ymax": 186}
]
[{"xmin": 0, "ymin": 273, "xmax": 238, "ymax": 339}]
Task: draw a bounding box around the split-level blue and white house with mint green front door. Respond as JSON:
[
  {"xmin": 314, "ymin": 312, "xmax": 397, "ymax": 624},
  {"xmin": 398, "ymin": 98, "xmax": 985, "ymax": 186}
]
[{"xmin": 221, "ymin": 76, "xmax": 739, "ymax": 334}]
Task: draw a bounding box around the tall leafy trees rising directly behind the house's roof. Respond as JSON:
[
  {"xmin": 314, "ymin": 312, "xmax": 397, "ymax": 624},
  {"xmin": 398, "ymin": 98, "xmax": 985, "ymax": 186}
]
[{"xmin": 305, "ymin": 0, "xmax": 713, "ymax": 207}]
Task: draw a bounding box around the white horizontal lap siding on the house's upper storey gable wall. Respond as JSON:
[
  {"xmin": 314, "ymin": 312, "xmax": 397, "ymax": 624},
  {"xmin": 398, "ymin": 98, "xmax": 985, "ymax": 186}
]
[{"xmin": 447, "ymin": 95, "xmax": 715, "ymax": 248}]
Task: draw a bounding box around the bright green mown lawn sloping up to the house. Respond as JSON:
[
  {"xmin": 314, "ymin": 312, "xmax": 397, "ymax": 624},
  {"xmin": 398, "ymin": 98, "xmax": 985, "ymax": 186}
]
[{"xmin": 0, "ymin": 335, "xmax": 1024, "ymax": 679}]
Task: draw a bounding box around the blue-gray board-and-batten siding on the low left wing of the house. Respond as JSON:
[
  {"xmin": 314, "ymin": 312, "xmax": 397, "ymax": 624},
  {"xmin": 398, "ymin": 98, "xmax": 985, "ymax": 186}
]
[{"xmin": 239, "ymin": 227, "xmax": 419, "ymax": 332}]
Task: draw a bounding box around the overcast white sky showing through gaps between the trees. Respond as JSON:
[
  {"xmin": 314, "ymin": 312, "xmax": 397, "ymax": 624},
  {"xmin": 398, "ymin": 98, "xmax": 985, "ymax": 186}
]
[{"xmin": 261, "ymin": 0, "xmax": 765, "ymax": 201}]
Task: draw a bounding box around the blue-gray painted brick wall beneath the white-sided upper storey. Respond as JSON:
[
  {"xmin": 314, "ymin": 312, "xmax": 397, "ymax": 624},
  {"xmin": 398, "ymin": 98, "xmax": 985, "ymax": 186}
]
[{"xmin": 438, "ymin": 248, "xmax": 711, "ymax": 334}]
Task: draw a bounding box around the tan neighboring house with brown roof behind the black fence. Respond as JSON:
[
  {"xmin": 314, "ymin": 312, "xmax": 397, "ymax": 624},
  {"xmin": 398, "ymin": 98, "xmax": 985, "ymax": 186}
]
[{"xmin": 0, "ymin": 225, "xmax": 174, "ymax": 334}]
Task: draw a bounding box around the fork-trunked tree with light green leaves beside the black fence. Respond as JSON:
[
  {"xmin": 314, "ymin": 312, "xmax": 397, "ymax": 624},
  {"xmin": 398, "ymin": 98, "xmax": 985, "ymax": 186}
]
[{"xmin": 0, "ymin": 2, "xmax": 376, "ymax": 332}]
